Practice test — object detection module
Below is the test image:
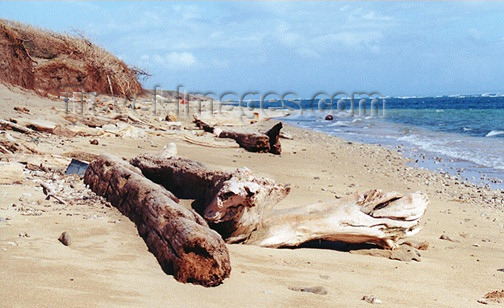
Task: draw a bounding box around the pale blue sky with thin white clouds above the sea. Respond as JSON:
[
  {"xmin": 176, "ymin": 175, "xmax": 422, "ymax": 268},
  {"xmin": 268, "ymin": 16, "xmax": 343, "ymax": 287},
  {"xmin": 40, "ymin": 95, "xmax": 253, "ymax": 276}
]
[{"xmin": 0, "ymin": 1, "xmax": 504, "ymax": 98}]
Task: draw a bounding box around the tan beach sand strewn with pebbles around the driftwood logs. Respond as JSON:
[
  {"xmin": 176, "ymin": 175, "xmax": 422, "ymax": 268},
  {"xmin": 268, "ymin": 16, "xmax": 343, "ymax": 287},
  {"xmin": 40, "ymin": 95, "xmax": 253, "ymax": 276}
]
[{"xmin": 0, "ymin": 86, "xmax": 504, "ymax": 307}]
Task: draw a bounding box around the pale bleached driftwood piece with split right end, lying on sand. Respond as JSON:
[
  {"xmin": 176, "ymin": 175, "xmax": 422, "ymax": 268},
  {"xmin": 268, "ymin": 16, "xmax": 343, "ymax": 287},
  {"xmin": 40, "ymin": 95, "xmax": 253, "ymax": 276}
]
[{"xmin": 247, "ymin": 190, "xmax": 428, "ymax": 248}]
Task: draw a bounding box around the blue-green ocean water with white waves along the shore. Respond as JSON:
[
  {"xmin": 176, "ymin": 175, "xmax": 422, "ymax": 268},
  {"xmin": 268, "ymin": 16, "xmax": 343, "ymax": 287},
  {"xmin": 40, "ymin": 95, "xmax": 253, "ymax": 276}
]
[{"xmin": 247, "ymin": 94, "xmax": 504, "ymax": 189}]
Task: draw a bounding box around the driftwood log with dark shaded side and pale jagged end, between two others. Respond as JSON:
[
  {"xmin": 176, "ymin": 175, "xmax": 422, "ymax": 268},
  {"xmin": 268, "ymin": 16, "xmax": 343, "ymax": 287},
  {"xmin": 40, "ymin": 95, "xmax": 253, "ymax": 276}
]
[{"xmin": 131, "ymin": 155, "xmax": 290, "ymax": 243}]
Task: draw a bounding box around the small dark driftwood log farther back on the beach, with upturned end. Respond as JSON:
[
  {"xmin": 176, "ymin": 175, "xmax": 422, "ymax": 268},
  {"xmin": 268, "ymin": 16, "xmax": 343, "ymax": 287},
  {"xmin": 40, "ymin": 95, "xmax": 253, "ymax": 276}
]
[{"xmin": 194, "ymin": 116, "xmax": 282, "ymax": 154}]
